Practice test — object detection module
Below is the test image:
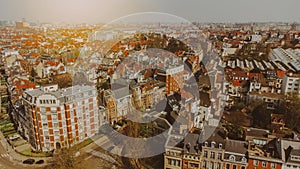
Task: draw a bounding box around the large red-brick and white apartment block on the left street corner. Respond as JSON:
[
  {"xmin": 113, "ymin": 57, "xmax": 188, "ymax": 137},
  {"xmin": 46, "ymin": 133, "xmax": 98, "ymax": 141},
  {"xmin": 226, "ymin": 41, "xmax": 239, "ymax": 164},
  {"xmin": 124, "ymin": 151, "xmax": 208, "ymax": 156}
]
[{"xmin": 21, "ymin": 85, "xmax": 99, "ymax": 151}]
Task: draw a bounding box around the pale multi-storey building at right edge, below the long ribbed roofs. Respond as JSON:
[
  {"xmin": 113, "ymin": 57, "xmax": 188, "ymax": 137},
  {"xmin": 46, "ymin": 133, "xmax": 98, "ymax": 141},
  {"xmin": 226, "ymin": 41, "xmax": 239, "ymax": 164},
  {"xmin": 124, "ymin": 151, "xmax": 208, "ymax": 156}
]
[{"xmin": 282, "ymin": 73, "xmax": 300, "ymax": 94}]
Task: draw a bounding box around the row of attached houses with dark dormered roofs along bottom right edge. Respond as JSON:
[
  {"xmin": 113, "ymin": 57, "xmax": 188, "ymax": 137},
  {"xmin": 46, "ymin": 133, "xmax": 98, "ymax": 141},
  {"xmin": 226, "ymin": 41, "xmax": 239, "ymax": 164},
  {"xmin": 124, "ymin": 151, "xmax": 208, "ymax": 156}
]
[{"xmin": 164, "ymin": 128, "xmax": 300, "ymax": 169}]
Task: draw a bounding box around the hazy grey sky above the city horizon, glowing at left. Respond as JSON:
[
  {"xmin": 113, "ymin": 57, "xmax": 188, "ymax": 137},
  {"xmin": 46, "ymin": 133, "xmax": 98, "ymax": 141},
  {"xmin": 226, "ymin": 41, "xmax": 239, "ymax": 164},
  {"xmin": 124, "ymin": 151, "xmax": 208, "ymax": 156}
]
[{"xmin": 0, "ymin": 0, "xmax": 300, "ymax": 23}]
